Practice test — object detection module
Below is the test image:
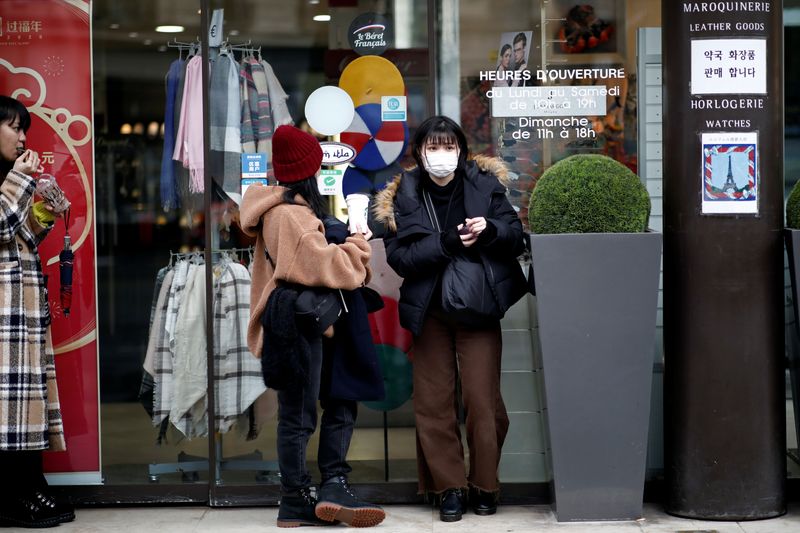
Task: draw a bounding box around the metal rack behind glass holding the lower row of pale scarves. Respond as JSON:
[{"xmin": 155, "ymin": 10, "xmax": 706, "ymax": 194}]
[{"xmin": 147, "ymin": 246, "xmax": 279, "ymax": 483}]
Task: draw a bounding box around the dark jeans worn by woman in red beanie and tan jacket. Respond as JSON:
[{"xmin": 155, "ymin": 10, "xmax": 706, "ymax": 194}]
[{"xmin": 278, "ymin": 337, "xmax": 358, "ymax": 492}]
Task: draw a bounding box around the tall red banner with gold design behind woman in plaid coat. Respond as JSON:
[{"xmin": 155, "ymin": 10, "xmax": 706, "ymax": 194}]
[{"xmin": 0, "ymin": 0, "xmax": 100, "ymax": 484}]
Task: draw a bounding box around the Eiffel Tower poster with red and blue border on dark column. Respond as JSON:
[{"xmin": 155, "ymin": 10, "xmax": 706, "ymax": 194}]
[{"xmin": 700, "ymin": 132, "xmax": 758, "ymax": 214}]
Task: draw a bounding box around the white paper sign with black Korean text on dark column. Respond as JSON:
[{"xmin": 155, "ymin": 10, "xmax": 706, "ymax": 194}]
[{"xmin": 692, "ymin": 39, "xmax": 767, "ymax": 94}]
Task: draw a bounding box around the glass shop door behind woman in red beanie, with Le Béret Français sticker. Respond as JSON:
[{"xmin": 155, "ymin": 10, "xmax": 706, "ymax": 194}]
[{"xmin": 209, "ymin": 0, "xmax": 432, "ymax": 504}]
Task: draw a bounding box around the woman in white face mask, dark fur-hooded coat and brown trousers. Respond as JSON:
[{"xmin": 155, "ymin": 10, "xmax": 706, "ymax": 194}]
[{"xmin": 375, "ymin": 116, "xmax": 524, "ymax": 522}]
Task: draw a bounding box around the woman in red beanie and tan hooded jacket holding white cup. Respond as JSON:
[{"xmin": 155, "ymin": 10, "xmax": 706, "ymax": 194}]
[{"xmin": 240, "ymin": 126, "xmax": 385, "ymax": 527}]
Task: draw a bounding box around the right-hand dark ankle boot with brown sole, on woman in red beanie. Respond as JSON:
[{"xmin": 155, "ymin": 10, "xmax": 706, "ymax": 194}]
[{"xmin": 316, "ymin": 476, "xmax": 386, "ymax": 527}]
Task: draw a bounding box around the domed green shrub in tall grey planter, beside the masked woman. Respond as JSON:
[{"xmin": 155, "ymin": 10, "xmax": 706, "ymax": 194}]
[{"xmin": 528, "ymin": 154, "xmax": 650, "ymax": 234}]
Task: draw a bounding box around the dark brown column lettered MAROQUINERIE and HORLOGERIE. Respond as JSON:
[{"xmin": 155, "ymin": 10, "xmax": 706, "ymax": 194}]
[{"xmin": 662, "ymin": 0, "xmax": 786, "ymax": 520}]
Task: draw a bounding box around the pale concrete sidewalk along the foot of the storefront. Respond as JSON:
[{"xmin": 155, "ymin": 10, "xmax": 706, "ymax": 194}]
[{"xmin": 47, "ymin": 504, "xmax": 800, "ymax": 533}]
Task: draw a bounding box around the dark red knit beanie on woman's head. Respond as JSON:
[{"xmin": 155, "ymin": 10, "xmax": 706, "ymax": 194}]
[{"xmin": 272, "ymin": 125, "xmax": 322, "ymax": 183}]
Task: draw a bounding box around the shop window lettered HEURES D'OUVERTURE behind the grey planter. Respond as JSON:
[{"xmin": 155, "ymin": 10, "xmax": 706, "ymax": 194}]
[{"xmin": 460, "ymin": 0, "xmax": 661, "ymax": 482}]
